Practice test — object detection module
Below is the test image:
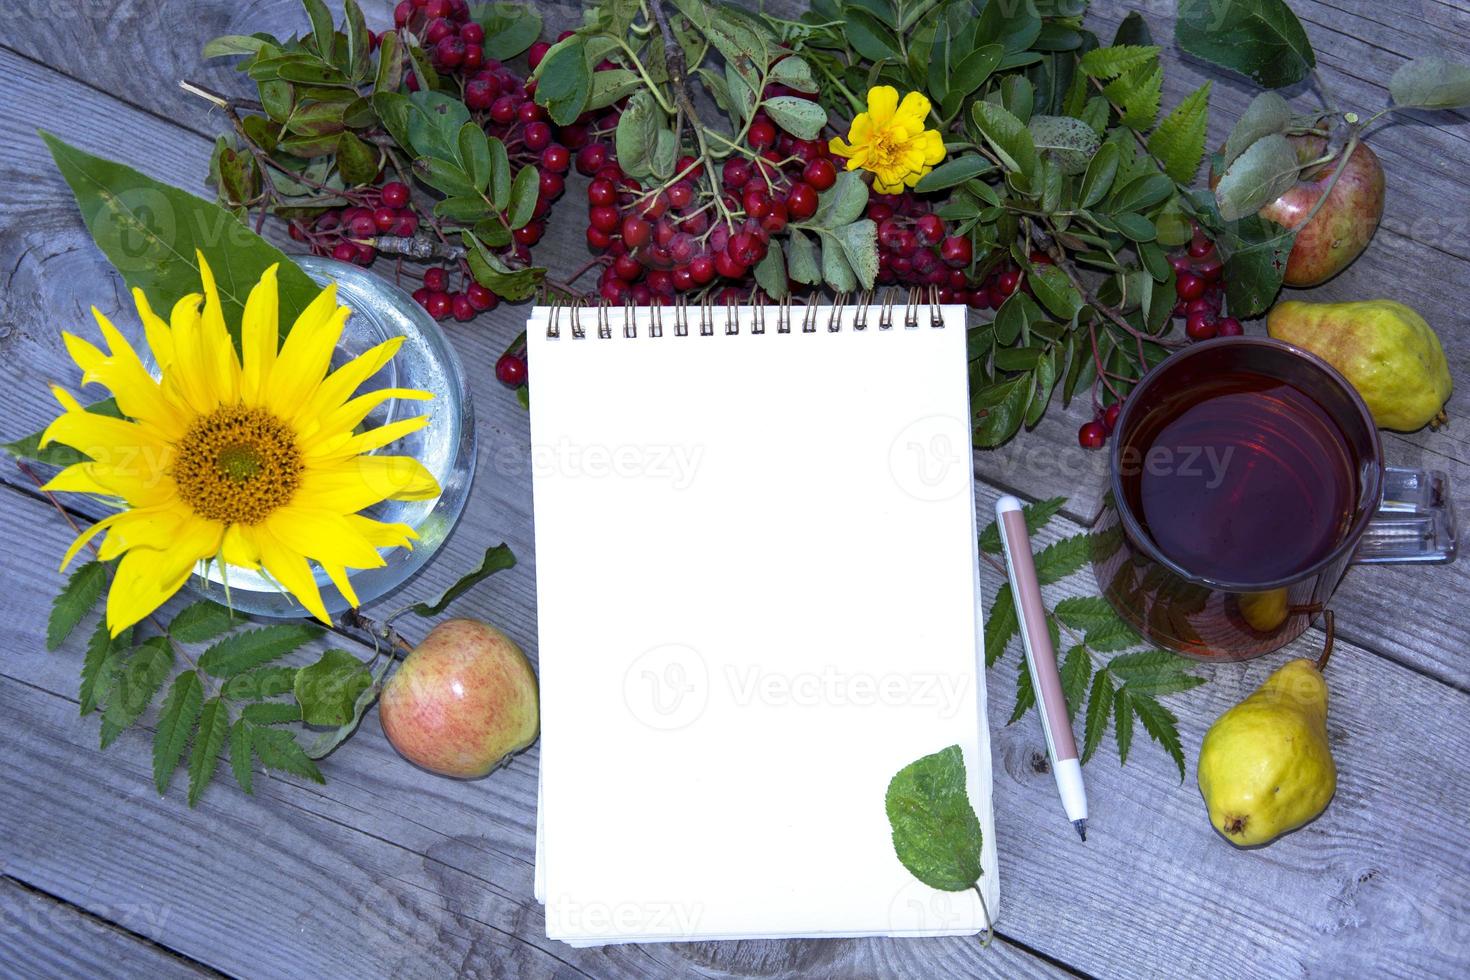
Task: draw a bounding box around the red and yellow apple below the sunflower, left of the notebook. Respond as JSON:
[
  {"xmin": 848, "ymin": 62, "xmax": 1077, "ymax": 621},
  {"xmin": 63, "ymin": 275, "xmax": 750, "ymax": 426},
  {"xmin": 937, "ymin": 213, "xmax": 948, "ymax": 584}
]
[{"xmin": 378, "ymin": 619, "xmax": 541, "ymax": 779}]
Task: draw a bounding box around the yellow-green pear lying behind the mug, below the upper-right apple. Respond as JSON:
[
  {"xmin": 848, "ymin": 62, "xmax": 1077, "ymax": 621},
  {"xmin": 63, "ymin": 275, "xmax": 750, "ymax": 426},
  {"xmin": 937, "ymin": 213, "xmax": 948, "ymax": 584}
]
[{"xmin": 1266, "ymin": 300, "xmax": 1451, "ymax": 432}]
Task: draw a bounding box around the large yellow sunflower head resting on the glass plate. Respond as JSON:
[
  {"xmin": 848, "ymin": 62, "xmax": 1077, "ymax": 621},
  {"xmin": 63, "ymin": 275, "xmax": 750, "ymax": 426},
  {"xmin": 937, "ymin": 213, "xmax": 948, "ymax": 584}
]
[{"xmin": 41, "ymin": 256, "xmax": 440, "ymax": 636}]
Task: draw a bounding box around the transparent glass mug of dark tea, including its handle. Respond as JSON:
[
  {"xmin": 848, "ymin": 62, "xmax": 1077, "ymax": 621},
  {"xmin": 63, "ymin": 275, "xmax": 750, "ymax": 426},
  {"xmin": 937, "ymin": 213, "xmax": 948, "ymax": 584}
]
[{"xmin": 1091, "ymin": 336, "xmax": 1455, "ymax": 660}]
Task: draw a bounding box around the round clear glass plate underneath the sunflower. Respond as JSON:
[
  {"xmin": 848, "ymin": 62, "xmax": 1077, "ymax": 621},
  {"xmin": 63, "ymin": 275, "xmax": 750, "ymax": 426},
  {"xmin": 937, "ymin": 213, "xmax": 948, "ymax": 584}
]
[{"xmin": 190, "ymin": 256, "xmax": 475, "ymax": 619}]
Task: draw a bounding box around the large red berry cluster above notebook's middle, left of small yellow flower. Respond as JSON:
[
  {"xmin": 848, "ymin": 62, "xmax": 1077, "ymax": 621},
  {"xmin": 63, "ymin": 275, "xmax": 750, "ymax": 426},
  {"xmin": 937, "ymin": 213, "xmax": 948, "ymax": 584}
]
[{"xmin": 558, "ymin": 64, "xmax": 838, "ymax": 306}]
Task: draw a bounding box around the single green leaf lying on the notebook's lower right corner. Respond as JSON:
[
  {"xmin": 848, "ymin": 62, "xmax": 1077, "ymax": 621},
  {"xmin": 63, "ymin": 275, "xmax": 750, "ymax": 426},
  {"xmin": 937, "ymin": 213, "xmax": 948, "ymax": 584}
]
[{"xmin": 883, "ymin": 745, "xmax": 983, "ymax": 892}]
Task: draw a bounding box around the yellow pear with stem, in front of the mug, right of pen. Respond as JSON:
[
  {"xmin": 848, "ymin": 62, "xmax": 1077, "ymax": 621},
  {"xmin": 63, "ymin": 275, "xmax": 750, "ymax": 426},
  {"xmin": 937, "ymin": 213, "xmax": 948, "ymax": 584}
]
[{"xmin": 1197, "ymin": 660, "xmax": 1338, "ymax": 848}]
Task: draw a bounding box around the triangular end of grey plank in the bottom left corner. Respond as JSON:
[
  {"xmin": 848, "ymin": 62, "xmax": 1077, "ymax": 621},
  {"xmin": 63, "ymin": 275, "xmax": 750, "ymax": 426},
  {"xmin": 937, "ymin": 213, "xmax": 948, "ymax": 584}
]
[{"xmin": 0, "ymin": 877, "xmax": 212, "ymax": 980}]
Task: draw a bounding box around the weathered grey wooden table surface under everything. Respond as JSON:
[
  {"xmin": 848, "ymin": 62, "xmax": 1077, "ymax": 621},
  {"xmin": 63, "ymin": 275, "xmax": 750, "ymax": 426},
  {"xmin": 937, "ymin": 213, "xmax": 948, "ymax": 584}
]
[{"xmin": 0, "ymin": 0, "xmax": 1470, "ymax": 977}]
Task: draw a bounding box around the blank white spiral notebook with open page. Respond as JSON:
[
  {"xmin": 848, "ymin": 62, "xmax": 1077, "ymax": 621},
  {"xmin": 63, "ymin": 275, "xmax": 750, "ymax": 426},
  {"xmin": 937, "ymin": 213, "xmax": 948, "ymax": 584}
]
[{"xmin": 528, "ymin": 300, "xmax": 998, "ymax": 945}]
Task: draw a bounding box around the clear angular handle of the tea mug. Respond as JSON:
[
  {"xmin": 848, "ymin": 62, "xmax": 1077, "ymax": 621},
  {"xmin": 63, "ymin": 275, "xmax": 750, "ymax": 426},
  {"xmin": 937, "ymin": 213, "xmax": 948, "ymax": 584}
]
[{"xmin": 1352, "ymin": 466, "xmax": 1457, "ymax": 564}]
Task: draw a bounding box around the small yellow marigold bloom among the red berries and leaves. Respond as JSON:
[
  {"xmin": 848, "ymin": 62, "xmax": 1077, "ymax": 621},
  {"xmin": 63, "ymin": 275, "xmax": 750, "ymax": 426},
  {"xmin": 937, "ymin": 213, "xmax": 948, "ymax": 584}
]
[{"xmin": 828, "ymin": 85, "xmax": 944, "ymax": 194}]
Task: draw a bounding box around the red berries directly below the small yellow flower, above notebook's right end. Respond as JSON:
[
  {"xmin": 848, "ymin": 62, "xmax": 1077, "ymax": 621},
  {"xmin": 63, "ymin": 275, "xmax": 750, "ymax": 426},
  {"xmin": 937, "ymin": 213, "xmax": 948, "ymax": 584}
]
[{"xmin": 867, "ymin": 191, "xmax": 975, "ymax": 295}]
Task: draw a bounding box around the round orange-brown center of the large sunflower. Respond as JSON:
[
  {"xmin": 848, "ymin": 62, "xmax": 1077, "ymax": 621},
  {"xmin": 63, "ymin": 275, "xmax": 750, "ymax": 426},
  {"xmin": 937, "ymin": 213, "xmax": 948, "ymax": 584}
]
[{"xmin": 173, "ymin": 406, "xmax": 301, "ymax": 525}]
